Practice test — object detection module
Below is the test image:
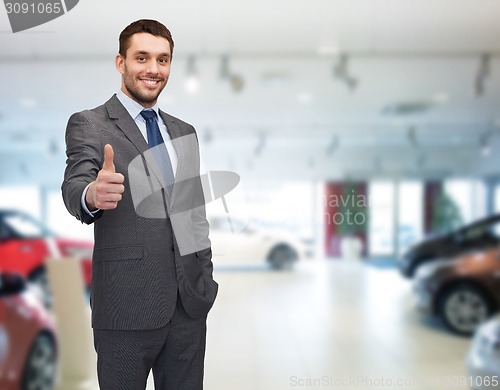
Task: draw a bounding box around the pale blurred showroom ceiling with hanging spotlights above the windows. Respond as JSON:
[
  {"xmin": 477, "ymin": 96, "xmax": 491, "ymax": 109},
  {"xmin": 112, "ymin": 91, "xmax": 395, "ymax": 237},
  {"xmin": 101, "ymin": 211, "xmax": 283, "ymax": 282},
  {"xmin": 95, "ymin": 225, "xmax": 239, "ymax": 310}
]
[{"xmin": 0, "ymin": 0, "xmax": 500, "ymax": 185}]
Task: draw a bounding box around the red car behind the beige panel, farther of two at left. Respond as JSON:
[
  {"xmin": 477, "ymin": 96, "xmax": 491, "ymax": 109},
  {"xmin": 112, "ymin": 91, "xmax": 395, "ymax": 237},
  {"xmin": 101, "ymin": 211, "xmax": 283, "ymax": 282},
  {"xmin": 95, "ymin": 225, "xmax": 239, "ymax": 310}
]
[{"xmin": 0, "ymin": 210, "xmax": 93, "ymax": 304}]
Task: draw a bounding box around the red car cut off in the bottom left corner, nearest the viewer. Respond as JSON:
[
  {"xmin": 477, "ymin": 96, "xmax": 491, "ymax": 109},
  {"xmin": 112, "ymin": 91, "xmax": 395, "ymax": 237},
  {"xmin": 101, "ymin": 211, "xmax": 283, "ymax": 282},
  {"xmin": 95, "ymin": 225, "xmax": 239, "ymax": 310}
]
[{"xmin": 0, "ymin": 273, "xmax": 57, "ymax": 390}]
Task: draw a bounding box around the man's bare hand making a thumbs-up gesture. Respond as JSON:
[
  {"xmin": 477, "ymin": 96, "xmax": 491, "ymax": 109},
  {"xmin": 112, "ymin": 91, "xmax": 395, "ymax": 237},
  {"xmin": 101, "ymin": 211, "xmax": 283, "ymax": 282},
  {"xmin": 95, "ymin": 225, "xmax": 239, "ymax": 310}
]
[{"xmin": 85, "ymin": 144, "xmax": 125, "ymax": 211}]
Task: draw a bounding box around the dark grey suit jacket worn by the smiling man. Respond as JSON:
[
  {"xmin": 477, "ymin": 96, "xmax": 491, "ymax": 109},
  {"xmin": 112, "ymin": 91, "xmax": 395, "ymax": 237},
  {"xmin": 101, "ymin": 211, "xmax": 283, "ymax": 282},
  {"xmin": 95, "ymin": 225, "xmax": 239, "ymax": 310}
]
[{"xmin": 62, "ymin": 95, "xmax": 218, "ymax": 330}]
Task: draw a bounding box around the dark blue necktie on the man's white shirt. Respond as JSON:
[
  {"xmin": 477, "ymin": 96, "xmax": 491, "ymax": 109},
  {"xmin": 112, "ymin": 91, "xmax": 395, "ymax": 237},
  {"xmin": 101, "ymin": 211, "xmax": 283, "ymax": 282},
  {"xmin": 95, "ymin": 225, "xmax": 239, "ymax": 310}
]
[{"xmin": 141, "ymin": 110, "xmax": 175, "ymax": 193}]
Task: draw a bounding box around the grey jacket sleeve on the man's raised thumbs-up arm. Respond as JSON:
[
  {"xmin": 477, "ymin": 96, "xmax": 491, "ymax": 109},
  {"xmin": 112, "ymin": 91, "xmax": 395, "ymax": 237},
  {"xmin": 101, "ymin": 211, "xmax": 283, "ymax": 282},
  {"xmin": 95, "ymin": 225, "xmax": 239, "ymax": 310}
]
[{"xmin": 61, "ymin": 111, "xmax": 104, "ymax": 224}]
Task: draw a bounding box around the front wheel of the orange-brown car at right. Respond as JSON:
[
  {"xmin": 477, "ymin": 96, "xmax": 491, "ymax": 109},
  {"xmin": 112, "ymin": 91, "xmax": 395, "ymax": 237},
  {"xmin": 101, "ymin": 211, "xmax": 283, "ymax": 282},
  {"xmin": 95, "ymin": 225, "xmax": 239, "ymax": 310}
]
[{"xmin": 439, "ymin": 283, "xmax": 492, "ymax": 335}]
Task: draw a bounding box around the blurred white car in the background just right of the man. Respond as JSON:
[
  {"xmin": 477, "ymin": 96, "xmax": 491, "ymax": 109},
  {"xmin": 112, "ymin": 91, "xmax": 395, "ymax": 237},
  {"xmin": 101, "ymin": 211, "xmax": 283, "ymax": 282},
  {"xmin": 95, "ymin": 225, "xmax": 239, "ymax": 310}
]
[{"xmin": 208, "ymin": 215, "xmax": 304, "ymax": 269}]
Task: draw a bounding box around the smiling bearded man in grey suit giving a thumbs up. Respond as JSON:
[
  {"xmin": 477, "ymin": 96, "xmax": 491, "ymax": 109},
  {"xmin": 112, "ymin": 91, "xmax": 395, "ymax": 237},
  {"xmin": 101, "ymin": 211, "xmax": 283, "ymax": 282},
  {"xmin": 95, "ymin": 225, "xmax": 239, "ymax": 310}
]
[{"xmin": 62, "ymin": 20, "xmax": 218, "ymax": 390}]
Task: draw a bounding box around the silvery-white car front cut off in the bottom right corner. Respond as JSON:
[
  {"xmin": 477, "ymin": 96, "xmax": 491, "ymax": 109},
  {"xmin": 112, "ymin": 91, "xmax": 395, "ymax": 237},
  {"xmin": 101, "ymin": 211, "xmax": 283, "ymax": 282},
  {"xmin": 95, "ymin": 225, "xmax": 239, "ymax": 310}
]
[{"xmin": 467, "ymin": 314, "xmax": 500, "ymax": 390}]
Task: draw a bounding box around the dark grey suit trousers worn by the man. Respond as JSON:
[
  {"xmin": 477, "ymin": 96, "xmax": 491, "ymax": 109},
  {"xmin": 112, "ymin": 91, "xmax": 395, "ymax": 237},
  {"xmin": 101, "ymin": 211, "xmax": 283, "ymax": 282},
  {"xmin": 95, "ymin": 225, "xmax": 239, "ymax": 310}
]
[{"xmin": 94, "ymin": 298, "xmax": 206, "ymax": 390}]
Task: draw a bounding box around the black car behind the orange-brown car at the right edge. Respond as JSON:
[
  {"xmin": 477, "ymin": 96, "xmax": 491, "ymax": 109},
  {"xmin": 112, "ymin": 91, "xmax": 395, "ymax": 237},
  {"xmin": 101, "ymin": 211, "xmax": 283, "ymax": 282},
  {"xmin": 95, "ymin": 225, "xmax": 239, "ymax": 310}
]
[{"xmin": 399, "ymin": 214, "xmax": 500, "ymax": 278}]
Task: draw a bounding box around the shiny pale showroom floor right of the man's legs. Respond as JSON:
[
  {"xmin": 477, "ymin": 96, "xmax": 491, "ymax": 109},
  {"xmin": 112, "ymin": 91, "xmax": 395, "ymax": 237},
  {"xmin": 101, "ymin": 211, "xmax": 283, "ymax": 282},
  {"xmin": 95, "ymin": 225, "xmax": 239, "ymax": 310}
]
[{"xmin": 144, "ymin": 260, "xmax": 470, "ymax": 390}]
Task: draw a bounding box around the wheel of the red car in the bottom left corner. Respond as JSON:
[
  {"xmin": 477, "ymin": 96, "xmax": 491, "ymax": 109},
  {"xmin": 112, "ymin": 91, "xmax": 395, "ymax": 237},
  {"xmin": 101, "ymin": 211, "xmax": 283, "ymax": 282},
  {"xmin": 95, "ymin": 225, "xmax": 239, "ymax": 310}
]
[{"xmin": 21, "ymin": 333, "xmax": 56, "ymax": 390}]
